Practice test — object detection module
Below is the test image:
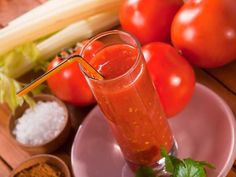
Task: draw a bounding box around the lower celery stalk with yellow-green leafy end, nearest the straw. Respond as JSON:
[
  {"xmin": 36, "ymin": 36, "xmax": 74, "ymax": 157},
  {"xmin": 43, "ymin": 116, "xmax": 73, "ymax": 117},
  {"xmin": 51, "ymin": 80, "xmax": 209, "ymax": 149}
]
[{"xmin": 0, "ymin": 12, "xmax": 119, "ymax": 78}]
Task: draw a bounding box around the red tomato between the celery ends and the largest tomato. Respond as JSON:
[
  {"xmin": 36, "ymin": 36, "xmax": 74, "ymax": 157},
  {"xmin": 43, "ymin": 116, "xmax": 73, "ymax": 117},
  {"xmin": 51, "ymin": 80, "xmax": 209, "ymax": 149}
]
[{"xmin": 119, "ymin": 0, "xmax": 183, "ymax": 44}]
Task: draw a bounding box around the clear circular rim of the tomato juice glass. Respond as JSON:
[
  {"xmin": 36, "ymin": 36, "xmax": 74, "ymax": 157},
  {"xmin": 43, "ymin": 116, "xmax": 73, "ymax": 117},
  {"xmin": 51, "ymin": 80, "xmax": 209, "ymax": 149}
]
[{"xmin": 79, "ymin": 30, "xmax": 142, "ymax": 82}]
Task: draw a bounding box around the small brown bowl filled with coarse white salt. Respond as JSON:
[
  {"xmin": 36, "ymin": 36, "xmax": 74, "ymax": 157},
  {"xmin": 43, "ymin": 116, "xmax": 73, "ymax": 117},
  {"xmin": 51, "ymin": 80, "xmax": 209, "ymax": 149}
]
[{"xmin": 8, "ymin": 94, "xmax": 70, "ymax": 154}]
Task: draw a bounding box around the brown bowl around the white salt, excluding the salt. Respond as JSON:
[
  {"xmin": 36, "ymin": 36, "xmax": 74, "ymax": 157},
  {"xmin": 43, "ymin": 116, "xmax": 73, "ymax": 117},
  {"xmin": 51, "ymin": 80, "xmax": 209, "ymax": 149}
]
[{"xmin": 8, "ymin": 94, "xmax": 71, "ymax": 154}]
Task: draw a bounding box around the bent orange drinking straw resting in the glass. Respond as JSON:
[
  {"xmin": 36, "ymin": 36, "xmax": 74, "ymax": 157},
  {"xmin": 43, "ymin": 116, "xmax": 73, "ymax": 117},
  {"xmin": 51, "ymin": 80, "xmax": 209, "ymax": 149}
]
[{"xmin": 16, "ymin": 55, "xmax": 104, "ymax": 96}]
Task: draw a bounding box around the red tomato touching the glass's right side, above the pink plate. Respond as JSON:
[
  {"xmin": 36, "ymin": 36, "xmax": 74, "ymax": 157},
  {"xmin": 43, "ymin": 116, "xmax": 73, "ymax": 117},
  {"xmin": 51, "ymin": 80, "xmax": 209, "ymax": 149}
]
[{"xmin": 142, "ymin": 42, "xmax": 195, "ymax": 117}]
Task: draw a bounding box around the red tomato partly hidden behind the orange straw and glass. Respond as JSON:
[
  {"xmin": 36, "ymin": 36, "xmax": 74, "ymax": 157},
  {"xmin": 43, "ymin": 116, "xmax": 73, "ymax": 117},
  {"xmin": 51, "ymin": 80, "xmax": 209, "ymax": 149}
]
[{"xmin": 47, "ymin": 42, "xmax": 103, "ymax": 106}]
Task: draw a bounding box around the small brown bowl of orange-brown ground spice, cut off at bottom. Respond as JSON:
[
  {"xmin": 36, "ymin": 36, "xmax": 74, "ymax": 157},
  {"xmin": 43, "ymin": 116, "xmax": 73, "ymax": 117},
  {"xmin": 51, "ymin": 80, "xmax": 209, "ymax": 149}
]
[{"xmin": 10, "ymin": 154, "xmax": 71, "ymax": 177}]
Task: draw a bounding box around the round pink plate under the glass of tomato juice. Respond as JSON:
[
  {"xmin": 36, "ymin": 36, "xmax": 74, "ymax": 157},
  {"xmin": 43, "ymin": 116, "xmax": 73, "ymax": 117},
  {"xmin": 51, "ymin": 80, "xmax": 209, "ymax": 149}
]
[{"xmin": 71, "ymin": 84, "xmax": 236, "ymax": 177}]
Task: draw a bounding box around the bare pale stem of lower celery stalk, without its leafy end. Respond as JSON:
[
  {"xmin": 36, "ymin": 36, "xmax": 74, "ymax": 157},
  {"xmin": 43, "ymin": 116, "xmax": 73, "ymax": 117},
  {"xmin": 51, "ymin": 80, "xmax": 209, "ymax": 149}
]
[{"xmin": 37, "ymin": 12, "xmax": 119, "ymax": 58}]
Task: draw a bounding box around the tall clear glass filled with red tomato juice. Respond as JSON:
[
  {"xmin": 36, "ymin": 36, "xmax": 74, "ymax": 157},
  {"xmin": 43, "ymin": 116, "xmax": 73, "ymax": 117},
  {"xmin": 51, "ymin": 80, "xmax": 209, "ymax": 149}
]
[{"xmin": 81, "ymin": 30, "xmax": 175, "ymax": 167}]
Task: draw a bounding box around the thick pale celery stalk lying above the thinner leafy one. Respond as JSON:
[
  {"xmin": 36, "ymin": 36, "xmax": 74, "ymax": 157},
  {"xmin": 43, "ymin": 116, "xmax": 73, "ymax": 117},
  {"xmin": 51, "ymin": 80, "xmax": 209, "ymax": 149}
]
[{"xmin": 0, "ymin": 0, "xmax": 120, "ymax": 54}]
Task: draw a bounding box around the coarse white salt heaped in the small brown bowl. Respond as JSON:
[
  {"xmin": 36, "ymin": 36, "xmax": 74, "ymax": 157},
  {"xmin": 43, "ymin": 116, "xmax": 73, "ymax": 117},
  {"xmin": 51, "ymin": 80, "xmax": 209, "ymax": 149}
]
[{"xmin": 13, "ymin": 101, "xmax": 66, "ymax": 145}]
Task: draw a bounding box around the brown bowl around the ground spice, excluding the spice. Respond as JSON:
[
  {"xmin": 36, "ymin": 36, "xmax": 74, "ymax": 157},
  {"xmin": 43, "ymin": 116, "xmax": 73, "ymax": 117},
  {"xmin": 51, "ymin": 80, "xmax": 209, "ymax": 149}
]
[{"xmin": 10, "ymin": 154, "xmax": 71, "ymax": 177}]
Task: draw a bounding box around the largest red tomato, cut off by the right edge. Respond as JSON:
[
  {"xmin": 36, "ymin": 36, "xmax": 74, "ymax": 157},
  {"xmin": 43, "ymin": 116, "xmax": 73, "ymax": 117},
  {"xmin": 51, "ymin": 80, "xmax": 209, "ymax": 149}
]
[{"xmin": 171, "ymin": 0, "xmax": 236, "ymax": 68}]
